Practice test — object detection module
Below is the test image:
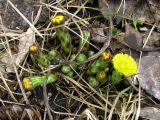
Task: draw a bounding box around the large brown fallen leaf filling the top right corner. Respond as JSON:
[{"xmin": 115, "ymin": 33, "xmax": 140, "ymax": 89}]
[{"xmin": 99, "ymin": 0, "xmax": 160, "ymax": 24}]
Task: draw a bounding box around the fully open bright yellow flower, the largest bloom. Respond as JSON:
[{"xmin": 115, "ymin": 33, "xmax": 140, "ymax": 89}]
[{"xmin": 112, "ymin": 53, "xmax": 138, "ymax": 77}]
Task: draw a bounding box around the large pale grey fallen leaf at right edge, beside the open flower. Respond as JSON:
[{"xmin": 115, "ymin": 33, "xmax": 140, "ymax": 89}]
[{"xmin": 137, "ymin": 56, "xmax": 160, "ymax": 100}]
